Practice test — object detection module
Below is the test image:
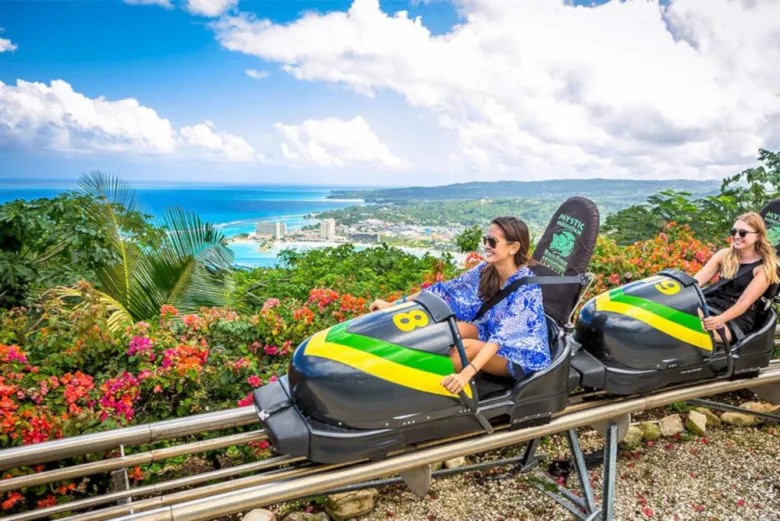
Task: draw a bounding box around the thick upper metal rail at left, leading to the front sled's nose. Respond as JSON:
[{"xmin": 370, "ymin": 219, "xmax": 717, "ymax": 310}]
[{"xmin": 0, "ymin": 405, "xmax": 259, "ymax": 470}]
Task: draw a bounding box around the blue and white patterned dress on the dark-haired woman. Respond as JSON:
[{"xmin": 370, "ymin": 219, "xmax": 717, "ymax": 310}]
[{"xmin": 423, "ymin": 262, "xmax": 550, "ymax": 378}]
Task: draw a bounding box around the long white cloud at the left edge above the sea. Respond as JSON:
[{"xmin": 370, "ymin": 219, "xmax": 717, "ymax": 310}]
[{"xmin": 0, "ymin": 80, "xmax": 262, "ymax": 161}]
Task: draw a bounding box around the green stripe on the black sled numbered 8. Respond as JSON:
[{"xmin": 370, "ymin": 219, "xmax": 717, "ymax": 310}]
[{"xmin": 326, "ymin": 322, "xmax": 455, "ymax": 376}]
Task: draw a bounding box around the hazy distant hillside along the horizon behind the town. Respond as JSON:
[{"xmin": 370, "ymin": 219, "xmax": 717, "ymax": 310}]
[{"xmin": 328, "ymin": 179, "xmax": 720, "ymax": 203}]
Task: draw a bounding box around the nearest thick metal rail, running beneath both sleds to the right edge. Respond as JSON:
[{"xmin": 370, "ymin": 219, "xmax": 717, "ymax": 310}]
[{"xmin": 108, "ymin": 369, "xmax": 780, "ymax": 521}]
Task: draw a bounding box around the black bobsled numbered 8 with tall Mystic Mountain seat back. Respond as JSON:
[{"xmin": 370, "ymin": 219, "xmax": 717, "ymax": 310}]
[{"xmin": 254, "ymin": 197, "xmax": 599, "ymax": 463}]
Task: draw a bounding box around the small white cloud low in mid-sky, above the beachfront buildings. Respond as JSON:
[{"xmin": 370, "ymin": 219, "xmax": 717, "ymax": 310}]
[{"xmin": 275, "ymin": 116, "xmax": 410, "ymax": 169}]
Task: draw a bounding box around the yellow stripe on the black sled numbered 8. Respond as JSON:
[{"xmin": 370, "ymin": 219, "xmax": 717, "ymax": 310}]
[{"xmin": 304, "ymin": 329, "xmax": 471, "ymax": 398}]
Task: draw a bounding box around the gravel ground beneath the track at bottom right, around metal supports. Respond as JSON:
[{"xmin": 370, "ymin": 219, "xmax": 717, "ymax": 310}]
[{"xmin": 348, "ymin": 426, "xmax": 780, "ymax": 521}]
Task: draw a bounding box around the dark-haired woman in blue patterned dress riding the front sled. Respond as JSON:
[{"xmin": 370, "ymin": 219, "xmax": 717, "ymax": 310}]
[{"xmin": 370, "ymin": 217, "xmax": 550, "ymax": 394}]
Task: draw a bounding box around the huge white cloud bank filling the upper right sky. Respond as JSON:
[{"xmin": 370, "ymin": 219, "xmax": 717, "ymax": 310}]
[{"xmin": 212, "ymin": 0, "xmax": 780, "ymax": 178}]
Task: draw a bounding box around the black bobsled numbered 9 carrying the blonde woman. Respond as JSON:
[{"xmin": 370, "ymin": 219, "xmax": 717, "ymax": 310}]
[{"xmin": 571, "ymin": 200, "xmax": 780, "ymax": 395}]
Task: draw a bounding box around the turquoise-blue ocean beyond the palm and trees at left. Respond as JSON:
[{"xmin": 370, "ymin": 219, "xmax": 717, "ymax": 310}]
[{"xmin": 0, "ymin": 185, "xmax": 362, "ymax": 266}]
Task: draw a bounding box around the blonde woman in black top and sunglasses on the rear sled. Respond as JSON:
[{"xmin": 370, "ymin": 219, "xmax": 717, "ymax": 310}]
[{"xmin": 694, "ymin": 212, "xmax": 780, "ymax": 342}]
